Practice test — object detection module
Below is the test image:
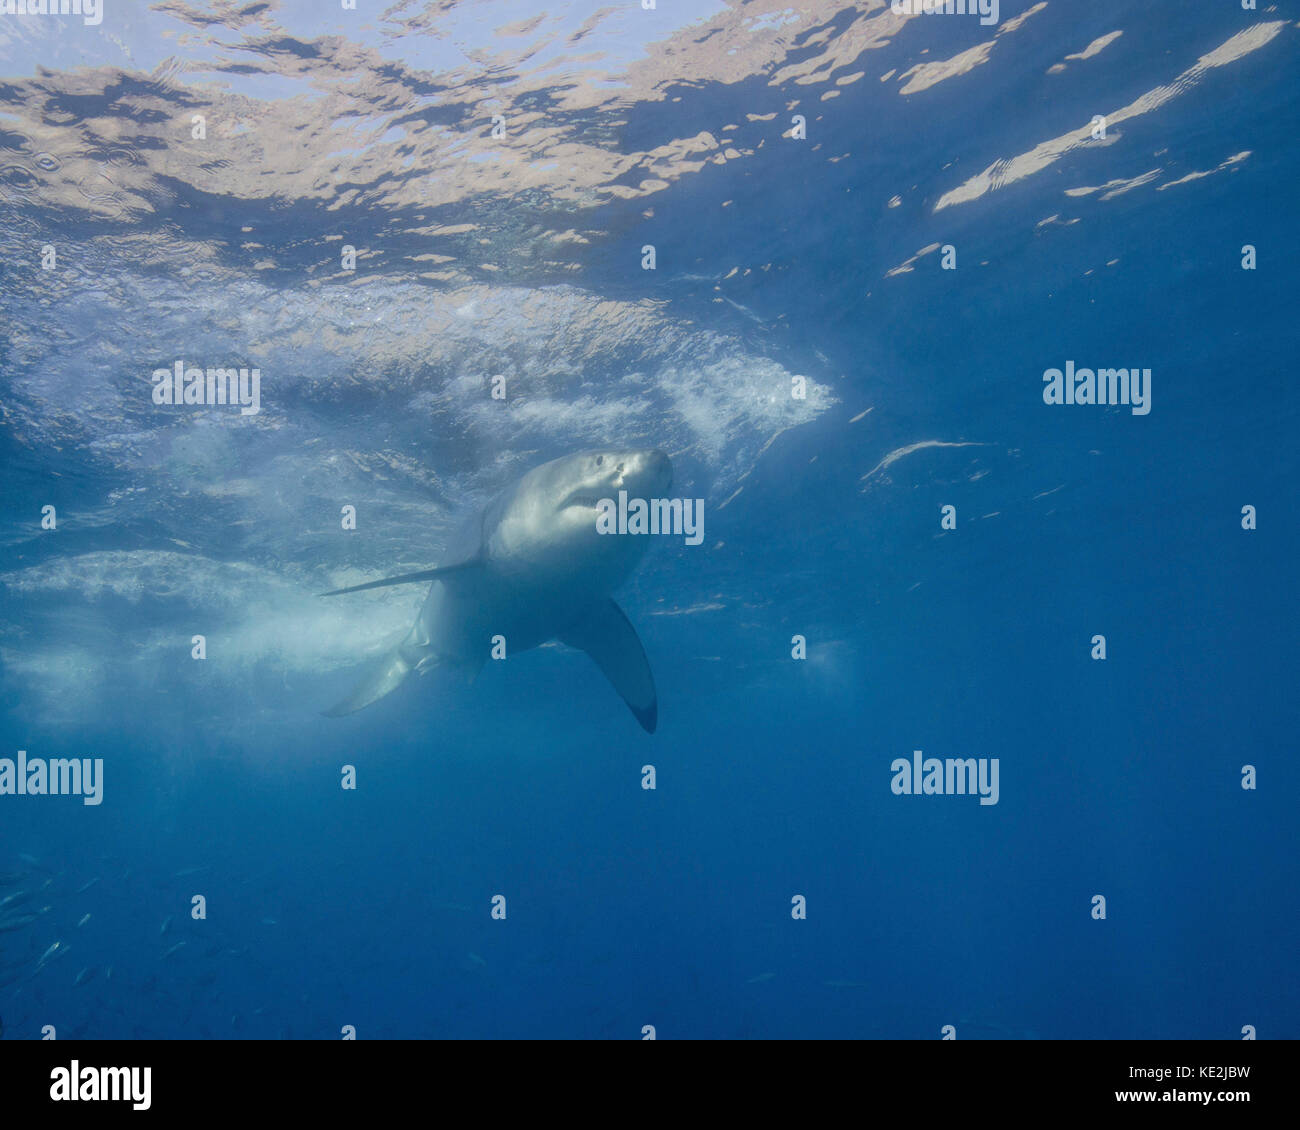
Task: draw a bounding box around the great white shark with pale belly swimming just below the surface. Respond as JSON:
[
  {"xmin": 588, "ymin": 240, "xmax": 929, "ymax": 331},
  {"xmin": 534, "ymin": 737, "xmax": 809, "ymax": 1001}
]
[{"xmin": 321, "ymin": 450, "xmax": 672, "ymax": 733}]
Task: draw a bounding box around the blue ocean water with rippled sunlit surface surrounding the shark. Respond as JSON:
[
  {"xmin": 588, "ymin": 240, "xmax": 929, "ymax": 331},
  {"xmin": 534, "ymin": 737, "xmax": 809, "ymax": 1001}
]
[{"xmin": 0, "ymin": 0, "xmax": 1300, "ymax": 1039}]
